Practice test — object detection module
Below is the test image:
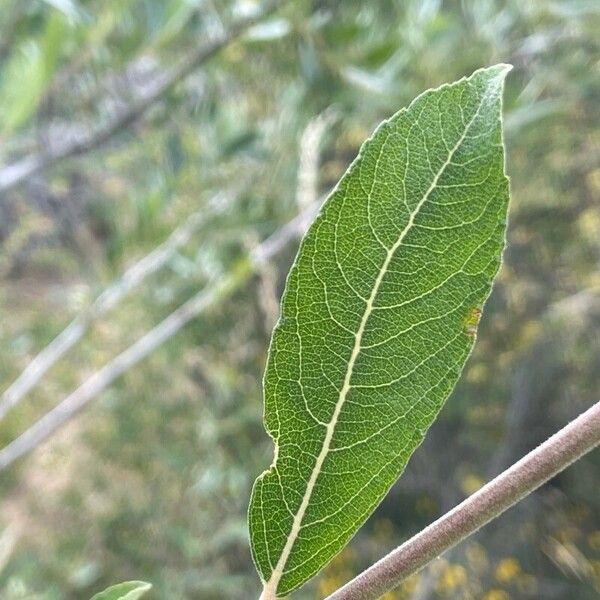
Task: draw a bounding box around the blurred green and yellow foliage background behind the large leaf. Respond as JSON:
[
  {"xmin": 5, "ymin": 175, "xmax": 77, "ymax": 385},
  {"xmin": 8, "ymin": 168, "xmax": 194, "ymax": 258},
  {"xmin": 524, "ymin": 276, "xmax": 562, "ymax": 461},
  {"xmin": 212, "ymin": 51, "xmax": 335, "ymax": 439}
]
[{"xmin": 0, "ymin": 0, "xmax": 600, "ymax": 600}]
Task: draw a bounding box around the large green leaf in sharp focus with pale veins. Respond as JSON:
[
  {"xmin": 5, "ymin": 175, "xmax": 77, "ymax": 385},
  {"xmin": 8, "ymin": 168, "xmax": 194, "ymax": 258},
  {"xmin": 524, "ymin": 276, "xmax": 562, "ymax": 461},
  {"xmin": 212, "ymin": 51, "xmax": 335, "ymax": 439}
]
[{"xmin": 249, "ymin": 65, "xmax": 510, "ymax": 600}]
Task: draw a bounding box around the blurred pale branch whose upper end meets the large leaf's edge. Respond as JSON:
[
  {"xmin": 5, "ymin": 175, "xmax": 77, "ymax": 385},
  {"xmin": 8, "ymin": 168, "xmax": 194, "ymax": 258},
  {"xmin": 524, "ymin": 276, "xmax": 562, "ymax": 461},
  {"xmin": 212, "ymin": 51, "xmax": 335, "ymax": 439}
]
[{"xmin": 0, "ymin": 202, "xmax": 320, "ymax": 471}]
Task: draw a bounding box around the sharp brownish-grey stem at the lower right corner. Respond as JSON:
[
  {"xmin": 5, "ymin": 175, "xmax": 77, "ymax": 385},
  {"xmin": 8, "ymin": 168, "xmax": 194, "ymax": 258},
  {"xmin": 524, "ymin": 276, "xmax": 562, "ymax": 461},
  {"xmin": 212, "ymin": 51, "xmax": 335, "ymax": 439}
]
[{"xmin": 326, "ymin": 402, "xmax": 600, "ymax": 600}]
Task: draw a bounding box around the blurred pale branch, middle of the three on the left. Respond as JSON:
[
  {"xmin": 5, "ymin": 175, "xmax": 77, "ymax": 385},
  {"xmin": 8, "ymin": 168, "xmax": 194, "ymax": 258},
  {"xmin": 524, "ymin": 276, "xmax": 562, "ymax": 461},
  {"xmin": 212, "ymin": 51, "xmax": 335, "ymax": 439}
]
[{"xmin": 0, "ymin": 193, "xmax": 235, "ymax": 421}]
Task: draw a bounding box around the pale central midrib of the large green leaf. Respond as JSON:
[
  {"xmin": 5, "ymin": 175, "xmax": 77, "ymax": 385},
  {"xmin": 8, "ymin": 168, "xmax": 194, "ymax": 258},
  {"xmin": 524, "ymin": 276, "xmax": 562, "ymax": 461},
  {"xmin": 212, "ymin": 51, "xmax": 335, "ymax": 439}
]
[{"xmin": 260, "ymin": 90, "xmax": 485, "ymax": 600}]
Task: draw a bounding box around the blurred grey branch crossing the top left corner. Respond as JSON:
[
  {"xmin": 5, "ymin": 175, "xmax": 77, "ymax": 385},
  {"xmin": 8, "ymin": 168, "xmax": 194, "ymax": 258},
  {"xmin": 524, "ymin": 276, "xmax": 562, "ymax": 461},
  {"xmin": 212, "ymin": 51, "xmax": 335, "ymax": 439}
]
[{"xmin": 0, "ymin": 0, "xmax": 281, "ymax": 193}]
